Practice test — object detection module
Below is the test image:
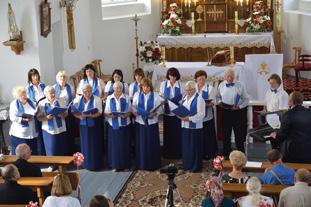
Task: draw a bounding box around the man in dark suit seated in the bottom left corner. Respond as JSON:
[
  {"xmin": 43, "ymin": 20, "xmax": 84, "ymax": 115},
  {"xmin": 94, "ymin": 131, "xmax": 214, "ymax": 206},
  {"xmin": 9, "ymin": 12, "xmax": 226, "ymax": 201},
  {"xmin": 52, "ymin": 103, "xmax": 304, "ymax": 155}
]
[{"xmin": 0, "ymin": 164, "xmax": 38, "ymax": 204}]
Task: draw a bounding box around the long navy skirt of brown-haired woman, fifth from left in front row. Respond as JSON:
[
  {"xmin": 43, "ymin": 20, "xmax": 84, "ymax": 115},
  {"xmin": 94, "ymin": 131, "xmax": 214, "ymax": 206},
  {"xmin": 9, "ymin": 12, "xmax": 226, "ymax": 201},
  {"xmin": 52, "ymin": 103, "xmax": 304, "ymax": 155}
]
[{"xmin": 136, "ymin": 123, "xmax": 161, "ymax": 170}]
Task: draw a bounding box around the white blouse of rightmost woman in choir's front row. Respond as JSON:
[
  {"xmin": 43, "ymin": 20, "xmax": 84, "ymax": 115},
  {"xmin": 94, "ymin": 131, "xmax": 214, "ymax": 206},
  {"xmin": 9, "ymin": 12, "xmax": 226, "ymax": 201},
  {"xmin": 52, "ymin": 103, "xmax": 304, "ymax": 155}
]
[{"xmin": 181, "ymin": 93, "xmax": 205, "ymax": 129}]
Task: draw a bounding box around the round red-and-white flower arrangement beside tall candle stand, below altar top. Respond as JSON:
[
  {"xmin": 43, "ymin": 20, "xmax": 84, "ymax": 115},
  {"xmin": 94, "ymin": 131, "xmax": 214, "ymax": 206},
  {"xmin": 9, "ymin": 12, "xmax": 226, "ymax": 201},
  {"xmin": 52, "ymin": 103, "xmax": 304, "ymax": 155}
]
[{"xmin": 139, "ymin": 41, "xmax": 161, "ymax": 64}]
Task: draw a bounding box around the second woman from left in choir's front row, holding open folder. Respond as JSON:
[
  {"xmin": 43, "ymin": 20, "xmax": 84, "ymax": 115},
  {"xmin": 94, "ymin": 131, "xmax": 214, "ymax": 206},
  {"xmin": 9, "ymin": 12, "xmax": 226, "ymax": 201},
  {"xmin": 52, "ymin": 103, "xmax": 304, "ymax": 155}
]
[{"xmin": 38, "ymin": 86, "xmax": 67, "ymax": 156}]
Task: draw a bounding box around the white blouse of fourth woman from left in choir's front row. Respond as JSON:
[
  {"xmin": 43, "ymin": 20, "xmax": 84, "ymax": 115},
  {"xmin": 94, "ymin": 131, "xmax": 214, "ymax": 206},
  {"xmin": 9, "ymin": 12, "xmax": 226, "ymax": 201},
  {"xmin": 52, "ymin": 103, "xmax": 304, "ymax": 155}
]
[{"xmin": 105, "ymin": 94, "xmax": 131, "ymax": 126}]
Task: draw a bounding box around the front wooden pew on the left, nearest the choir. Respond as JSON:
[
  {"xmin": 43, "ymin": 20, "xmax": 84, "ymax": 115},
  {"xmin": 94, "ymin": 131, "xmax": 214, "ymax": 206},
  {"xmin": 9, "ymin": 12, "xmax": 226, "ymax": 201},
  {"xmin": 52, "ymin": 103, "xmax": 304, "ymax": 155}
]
[{"xmin": 0, "ymin": 155, "xmax": 74, "ymax": 172}]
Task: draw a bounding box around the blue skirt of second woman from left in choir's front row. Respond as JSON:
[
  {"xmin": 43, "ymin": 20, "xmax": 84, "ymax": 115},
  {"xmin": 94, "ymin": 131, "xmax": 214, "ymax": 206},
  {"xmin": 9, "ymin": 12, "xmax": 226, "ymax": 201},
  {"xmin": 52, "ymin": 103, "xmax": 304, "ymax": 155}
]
[{"xmin": 42, "ymin": 130, "xmax": 67, "ymax": 156}]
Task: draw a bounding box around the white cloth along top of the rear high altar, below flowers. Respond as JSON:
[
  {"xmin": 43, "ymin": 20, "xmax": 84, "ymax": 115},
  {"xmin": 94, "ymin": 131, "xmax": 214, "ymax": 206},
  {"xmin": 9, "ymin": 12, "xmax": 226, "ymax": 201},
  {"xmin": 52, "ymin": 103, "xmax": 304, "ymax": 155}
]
[{"xmin": 157, "ymin": 32, "xmax": 275, "ymax": 52}]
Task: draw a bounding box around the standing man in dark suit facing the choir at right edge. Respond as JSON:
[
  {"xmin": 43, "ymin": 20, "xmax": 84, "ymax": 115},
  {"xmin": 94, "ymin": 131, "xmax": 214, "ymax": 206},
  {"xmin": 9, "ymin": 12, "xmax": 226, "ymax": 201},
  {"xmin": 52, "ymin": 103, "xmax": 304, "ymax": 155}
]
[{"xmin": 271, "ymin": 91, "xmax": 311, "ymax": 163}]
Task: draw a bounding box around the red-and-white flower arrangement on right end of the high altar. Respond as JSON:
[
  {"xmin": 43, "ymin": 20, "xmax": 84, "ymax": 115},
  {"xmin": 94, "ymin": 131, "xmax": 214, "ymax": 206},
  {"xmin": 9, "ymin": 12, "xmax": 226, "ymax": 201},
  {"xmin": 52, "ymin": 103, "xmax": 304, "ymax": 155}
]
[{"xmin": 245, "ymin": 0, "xmax": 272, "ymax": 32}]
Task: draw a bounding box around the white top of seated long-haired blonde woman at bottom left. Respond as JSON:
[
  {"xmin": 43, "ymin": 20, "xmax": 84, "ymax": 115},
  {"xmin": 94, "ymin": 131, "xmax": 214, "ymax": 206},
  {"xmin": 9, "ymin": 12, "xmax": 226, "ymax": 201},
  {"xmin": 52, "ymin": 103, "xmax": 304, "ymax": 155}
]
[{"xmin": 42, "ymin": 196, "xmax": 81, "ymax": 207}]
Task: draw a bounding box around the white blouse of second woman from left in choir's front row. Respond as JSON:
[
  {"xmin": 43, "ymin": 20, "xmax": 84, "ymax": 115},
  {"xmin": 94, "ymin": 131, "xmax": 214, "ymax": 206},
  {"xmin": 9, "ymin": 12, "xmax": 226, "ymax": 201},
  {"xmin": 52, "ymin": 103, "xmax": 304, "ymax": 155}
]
[{"xmin": 38, "ymin": 99, "xmax": 67, "ymax": 135}]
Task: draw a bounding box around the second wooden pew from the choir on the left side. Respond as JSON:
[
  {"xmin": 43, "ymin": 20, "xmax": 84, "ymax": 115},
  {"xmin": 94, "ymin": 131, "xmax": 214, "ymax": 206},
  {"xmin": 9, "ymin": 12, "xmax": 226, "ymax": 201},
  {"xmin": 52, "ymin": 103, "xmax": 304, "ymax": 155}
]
[{"xmin": 0, "ymin": 177, "xmax": 53, "ymax": 206}]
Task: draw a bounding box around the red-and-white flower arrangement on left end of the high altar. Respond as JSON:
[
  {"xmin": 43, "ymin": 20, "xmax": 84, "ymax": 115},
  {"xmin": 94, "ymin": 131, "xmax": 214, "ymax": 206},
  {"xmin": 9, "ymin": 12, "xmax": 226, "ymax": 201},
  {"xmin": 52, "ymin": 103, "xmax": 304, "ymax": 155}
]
[{"xmin": 160, "ymin": 3, "xmax": 186, "ymax": 35}]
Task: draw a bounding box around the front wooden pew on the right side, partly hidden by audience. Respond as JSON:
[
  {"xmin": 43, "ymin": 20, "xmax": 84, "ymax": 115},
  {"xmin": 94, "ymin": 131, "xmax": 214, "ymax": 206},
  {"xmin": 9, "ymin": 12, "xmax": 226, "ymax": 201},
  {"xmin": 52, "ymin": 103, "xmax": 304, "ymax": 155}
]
[{"xmin": 223, "ymin": 160, "xmax": 311, "ymax": 173}]
